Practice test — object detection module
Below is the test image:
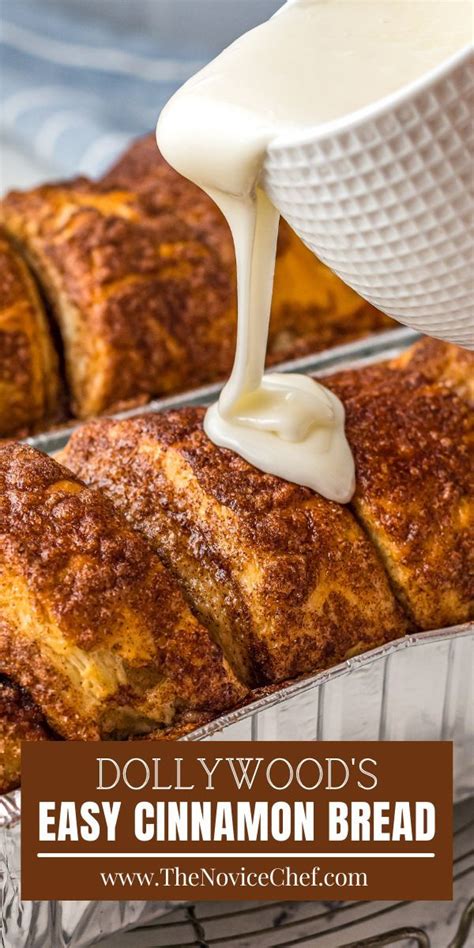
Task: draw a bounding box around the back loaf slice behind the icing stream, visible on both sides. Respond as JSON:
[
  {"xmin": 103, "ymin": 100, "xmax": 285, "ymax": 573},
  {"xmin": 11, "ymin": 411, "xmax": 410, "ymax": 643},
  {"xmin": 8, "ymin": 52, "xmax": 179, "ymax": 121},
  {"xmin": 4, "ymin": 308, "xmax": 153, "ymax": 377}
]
[{"xmin": 101, "ymin": 134, "xmax": 394, "ymax": 362}]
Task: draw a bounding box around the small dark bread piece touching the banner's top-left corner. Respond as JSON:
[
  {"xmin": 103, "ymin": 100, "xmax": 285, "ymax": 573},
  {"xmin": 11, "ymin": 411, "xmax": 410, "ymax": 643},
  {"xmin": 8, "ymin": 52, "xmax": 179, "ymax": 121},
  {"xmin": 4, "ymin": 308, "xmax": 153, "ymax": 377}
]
[{"xmin": 0, "ymin": 675, "xmax": 54, "ymax": 795}]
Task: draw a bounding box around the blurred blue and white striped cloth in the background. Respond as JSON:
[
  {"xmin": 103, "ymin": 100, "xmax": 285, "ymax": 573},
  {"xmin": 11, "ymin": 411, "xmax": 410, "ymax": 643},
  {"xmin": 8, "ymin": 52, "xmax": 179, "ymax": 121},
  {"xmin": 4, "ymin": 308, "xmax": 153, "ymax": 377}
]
[{"xmin": 0, "ymin": 0, "xmax": 283, "ymax": 176}]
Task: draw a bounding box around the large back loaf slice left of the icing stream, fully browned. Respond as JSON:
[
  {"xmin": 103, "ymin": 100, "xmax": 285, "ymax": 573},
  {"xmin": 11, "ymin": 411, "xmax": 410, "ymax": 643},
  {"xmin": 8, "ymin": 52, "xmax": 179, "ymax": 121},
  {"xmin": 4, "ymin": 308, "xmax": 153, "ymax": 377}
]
[{"xmin": 0, "ymin": 181, "xmax": 232, "ymax": 417}]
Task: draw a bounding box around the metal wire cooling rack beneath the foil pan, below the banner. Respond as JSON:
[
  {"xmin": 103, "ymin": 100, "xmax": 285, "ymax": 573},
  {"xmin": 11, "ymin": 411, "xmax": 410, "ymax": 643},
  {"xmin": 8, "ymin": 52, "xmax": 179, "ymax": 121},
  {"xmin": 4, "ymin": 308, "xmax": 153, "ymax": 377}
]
[{"xmin": 102, "ymin": 801, "xmax": 474, "ymax": 948}]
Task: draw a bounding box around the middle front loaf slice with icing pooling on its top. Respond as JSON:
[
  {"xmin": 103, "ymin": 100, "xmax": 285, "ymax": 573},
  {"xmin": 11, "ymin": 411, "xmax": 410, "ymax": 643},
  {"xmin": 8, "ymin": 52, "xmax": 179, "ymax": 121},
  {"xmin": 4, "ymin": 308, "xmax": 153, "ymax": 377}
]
[{"xmin": 64, "ymin": 408, "xmax": 406, "ymax": 684}]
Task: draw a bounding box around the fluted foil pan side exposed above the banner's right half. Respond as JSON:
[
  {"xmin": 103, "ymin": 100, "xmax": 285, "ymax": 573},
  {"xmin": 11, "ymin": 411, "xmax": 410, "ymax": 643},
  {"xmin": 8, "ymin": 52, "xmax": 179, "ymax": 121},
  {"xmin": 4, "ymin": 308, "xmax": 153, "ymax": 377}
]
[{"xmin": 193, "ymin": 623, "xmax": 474, "ymax": 802}]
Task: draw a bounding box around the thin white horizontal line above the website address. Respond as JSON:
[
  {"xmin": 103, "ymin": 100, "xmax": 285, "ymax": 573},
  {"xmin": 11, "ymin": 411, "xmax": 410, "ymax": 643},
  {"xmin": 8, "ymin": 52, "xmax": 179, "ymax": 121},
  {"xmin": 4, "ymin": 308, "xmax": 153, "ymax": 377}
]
[{"xmin": 37, "ymin": 852, "xmax": 435, "ymax": 859}]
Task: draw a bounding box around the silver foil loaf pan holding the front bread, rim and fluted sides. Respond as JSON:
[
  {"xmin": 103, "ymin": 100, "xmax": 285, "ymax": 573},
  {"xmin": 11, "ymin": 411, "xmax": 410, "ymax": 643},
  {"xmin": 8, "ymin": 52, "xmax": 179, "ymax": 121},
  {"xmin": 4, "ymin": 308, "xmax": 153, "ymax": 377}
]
[{"xmin": 0, "ymin": 329, "xmax": 474, "ymax": 948}]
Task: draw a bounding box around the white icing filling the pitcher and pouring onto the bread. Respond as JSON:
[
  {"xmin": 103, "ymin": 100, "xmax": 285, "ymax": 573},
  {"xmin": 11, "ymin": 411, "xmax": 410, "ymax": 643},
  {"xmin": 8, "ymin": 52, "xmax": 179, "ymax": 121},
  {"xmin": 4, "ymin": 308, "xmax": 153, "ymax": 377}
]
[{"xmin": 157, "ymin": 0, "xmax": 471, "ymax": 503}]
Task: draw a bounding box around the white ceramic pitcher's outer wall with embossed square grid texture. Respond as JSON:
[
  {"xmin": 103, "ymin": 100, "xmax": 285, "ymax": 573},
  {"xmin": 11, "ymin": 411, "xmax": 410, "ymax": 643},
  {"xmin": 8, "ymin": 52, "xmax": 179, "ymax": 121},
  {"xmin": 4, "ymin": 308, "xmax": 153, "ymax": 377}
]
[{"xmin": 263, "ymin": 47, "xmax": 474, "ymax": 348}]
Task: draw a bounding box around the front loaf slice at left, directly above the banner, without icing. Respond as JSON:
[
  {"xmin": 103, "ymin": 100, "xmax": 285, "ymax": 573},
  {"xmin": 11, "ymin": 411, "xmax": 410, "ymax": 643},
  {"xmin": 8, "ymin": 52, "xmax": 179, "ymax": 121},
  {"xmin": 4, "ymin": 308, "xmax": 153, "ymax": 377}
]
[{"xmin": 0, "ymin": 442, "xmax": 245, "ymax": 740}]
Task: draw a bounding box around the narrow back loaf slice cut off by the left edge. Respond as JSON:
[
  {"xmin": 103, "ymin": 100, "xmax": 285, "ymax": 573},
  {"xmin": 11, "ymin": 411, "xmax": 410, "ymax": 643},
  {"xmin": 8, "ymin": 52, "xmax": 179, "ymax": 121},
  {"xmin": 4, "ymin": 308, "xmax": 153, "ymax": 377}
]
[{"xmin": 0, "ymin": 229, "xmax": 61, "ymax": 437}]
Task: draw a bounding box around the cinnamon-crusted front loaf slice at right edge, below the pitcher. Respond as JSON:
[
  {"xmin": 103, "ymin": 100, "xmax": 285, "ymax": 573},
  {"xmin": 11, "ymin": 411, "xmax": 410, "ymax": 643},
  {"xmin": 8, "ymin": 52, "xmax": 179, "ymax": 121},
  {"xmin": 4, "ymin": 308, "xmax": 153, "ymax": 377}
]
[{"xmin": 324, "ymin": 340, "xmax": 474, "ymax": 629}]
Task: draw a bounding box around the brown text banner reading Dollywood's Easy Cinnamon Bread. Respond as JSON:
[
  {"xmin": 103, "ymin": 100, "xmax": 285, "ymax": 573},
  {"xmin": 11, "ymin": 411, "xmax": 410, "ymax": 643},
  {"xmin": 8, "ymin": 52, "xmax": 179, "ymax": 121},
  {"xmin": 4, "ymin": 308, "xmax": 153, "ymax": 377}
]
[{"xmin": 21, "ymin": 741, "xmax": 452, "ymax": 901}]
